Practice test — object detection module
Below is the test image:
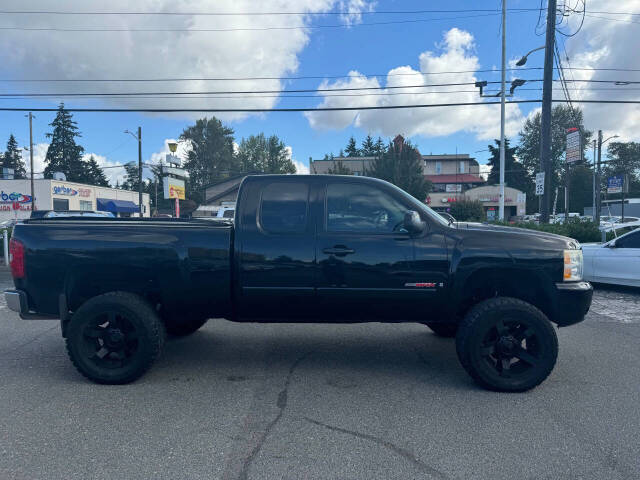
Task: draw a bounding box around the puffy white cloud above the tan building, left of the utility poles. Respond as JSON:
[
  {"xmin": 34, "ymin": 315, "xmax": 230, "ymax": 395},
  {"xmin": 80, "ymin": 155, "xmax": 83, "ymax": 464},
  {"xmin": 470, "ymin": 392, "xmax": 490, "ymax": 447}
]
[{"xmin": 305, "ymin": 28, "xmax": 523, "ymax": 140}]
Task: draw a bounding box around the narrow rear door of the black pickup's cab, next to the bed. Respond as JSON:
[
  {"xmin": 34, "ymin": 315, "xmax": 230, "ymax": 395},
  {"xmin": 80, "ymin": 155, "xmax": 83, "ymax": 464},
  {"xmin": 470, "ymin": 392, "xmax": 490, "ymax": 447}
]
[{"xmin": 236, "ymin": 176, "xmax": 316, "ymax": 319}]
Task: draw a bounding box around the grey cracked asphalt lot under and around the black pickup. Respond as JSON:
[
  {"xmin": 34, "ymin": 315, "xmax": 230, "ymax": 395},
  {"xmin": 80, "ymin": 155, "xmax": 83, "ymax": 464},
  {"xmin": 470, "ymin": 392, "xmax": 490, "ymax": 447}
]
[{"xmin": 0, "ymin": 269, "xmax": 640, "ymax": 480}]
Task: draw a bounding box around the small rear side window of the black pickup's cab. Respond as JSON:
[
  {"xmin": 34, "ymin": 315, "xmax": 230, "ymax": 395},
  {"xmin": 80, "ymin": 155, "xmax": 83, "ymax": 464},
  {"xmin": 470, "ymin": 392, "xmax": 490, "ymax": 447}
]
[{"xmin": 260, "ymin": 182, "xmax": 309, "ymax": 233}]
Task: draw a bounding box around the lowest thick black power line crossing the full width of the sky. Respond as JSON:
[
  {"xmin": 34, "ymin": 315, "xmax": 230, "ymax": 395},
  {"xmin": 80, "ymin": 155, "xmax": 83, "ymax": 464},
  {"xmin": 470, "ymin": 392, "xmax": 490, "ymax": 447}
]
[{"xmin": 0, "ymin": 99, "xmax": 640, "ymax": 113}]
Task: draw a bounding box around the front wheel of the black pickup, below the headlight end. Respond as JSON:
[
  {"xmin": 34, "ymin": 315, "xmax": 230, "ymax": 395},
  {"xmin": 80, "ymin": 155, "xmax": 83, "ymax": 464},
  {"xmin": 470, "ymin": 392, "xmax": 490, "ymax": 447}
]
[{"xmin": 456, "ymin": 297, "xmax": 558, "ymax": 392}]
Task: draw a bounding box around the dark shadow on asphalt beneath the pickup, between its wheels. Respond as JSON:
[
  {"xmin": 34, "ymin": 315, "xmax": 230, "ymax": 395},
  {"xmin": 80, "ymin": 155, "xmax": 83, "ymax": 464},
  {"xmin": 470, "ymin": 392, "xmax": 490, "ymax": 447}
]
[{"xmin": 155, "ymin": 320, "xmax": 476, "ymax": 390}]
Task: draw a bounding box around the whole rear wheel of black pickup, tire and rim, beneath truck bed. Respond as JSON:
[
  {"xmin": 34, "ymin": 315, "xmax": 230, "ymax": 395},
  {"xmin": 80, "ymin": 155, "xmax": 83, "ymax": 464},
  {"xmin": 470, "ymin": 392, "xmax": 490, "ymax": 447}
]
[{"xmin": 66, "ymin": 292, "xmax": 165, "ymax": 384}]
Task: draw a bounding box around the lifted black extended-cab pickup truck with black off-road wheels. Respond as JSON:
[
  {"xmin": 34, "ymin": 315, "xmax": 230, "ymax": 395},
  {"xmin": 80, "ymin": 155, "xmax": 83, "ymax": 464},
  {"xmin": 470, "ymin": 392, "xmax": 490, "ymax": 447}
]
[{"xmin": 5, "ymin": 175, "xmax": 592, "ymax": 391}]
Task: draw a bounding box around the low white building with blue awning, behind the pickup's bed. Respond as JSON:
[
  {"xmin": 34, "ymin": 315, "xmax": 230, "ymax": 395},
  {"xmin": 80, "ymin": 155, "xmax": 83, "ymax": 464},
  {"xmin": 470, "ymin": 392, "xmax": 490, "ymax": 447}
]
[{"xmin": 0, "ymin": 179, "xmax": 151, "ymax": 221}]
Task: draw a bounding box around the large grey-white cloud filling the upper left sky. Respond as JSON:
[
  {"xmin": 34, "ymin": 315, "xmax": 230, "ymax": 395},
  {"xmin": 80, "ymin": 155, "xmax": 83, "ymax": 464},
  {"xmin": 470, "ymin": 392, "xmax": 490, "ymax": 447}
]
[{"xmin": 0, "ymin": 0, "xmax": 373, "ymax": 120}]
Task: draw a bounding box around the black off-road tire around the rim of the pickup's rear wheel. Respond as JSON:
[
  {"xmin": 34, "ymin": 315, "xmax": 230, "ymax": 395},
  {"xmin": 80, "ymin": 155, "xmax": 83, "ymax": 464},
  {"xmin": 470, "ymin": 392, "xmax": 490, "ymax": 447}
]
[{"xmin": 66, "ymin": 292, "xmax": 166, "ymax": 385}]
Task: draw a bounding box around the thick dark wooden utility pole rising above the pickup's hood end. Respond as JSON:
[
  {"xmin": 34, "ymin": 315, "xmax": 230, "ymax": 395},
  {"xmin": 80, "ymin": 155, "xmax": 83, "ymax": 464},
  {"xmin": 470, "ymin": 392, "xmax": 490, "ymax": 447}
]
[{"xmin": 540, "ymin": 0, "xmax": 557, "ymax": 223}]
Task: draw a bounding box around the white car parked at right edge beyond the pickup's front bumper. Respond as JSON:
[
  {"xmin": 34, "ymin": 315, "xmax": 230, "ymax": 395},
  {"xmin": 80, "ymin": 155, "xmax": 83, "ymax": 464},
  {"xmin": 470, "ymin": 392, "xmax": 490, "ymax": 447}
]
[{"xmin": 582, "ymin": 228, "xmax": 640, "ymax": 287}]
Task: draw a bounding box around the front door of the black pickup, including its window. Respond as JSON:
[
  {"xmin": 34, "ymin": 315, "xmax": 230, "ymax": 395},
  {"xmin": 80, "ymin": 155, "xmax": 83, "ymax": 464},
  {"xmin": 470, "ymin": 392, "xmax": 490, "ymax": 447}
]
[{"xmin": 316, "ymin": 177, "xmax": 448, "ymax": 321}]
